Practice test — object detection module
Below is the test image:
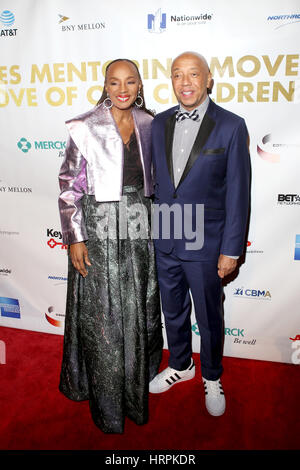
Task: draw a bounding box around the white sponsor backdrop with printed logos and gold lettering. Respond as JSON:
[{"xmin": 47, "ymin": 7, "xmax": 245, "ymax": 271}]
[{"xmin": 0, "ymin": 0, "xmax": 300, "ymax": 364}]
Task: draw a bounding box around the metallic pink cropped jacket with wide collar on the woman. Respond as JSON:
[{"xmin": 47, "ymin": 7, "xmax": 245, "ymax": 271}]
[{"xmin": 58, "ymin": 104, "xmax": 153, "ymax": 245}]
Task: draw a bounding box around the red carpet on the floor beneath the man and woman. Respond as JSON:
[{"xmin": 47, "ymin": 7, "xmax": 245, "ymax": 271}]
[{"xmin": 0, "ymin": 327, "xmax": 300, "ymax": 450}]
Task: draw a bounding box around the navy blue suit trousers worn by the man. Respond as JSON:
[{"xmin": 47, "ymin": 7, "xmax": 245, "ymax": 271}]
[{"xmin": 156, "ymin": 249, "xmax": 224, "ymax": 380}]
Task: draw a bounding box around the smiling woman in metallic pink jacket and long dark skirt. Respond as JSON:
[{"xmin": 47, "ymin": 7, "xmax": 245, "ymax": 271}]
[{"xmin": 59, "ymin": 59, "xmax": 163, "ymax": 433}]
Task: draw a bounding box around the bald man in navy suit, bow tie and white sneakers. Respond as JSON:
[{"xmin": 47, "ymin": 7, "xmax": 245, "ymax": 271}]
[{"xmin": 150, "ymin": 52, "xmax": 250, "ymax": 416}]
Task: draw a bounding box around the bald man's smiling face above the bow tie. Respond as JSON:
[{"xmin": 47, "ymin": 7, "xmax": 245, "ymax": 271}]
[{"xmin": 172, "ymin": 54, "xmax": 212, "ymax": 111}]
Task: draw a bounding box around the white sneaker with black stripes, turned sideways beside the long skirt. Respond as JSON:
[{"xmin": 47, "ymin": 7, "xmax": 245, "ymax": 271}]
[{"xmin": 149, "ymin": 359, "xmax": 195, "ymax": 393}]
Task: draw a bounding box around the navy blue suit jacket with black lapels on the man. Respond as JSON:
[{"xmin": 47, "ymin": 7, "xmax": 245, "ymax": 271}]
[{"xmin": 152, "ymin": 100, "xmax": 250, "ymax": 261}]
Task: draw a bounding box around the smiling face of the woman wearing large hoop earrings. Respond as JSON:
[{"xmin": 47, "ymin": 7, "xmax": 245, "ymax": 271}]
[{"xmin": 105, "ymin": 61, "xmax": 141, "ymax": 110}]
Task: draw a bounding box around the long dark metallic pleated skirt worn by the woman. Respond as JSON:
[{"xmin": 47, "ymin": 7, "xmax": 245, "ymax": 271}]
[{"xmin": 59, "ymin": 186, "xmax": 163, "ymax": 433}]
